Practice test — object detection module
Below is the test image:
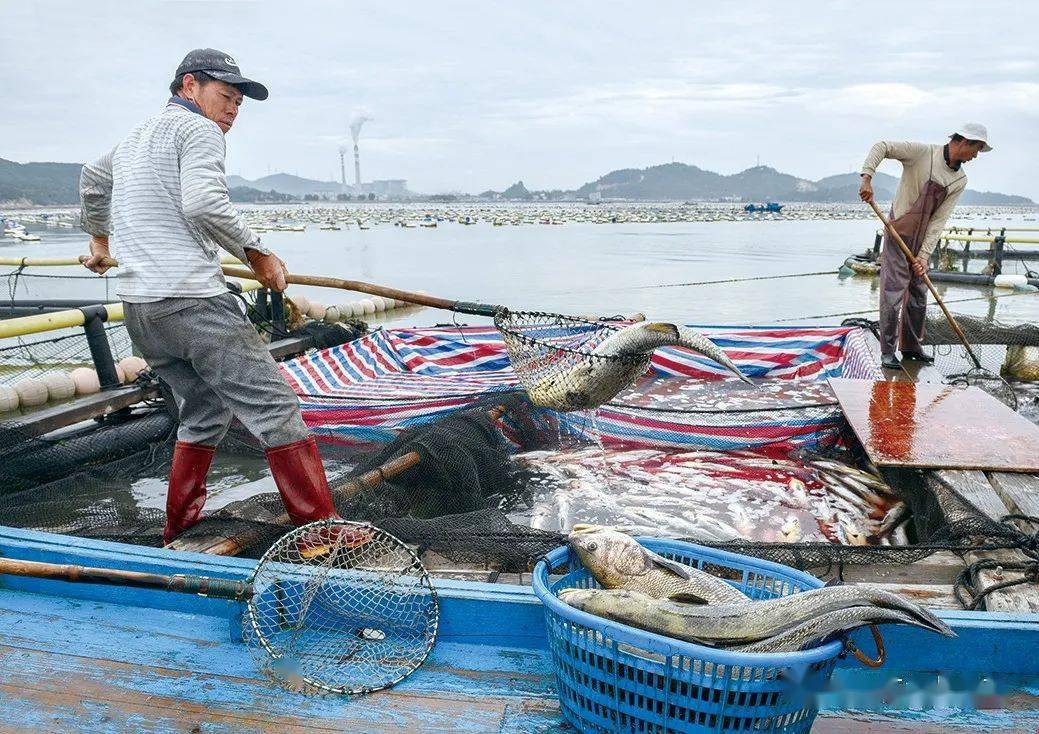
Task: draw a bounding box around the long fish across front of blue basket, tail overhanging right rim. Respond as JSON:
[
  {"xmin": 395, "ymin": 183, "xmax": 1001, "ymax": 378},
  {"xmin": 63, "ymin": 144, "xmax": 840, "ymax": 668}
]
[{"xmin": 559, "ymin": 585, "xmax": 953, "ymax": 646}]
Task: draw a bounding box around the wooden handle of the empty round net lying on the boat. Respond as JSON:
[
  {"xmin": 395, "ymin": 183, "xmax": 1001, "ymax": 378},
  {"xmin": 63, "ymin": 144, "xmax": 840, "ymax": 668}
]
[{"xmin": 0, "ymin": 558, "xmax": 252, "ymax": 601}]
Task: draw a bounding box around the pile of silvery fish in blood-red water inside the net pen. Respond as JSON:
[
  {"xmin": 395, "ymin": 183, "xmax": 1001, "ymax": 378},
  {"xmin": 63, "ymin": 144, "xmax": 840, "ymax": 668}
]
[{"xmin": 506, "ymin": 447, "xmax": 909, "ymax": 546}]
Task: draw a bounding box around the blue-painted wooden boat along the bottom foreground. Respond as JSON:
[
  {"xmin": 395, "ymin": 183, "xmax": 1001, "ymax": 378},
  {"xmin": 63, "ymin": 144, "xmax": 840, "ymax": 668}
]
[{"xmin": 0, "ymin": 529, "xmax": 1039, "ymax": 733}]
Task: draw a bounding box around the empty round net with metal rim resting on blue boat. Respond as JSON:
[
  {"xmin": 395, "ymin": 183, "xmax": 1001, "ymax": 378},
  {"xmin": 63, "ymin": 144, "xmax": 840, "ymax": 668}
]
[{"xmin": 243, "ymin": 520, "xmax": 439, "ymax": 693}]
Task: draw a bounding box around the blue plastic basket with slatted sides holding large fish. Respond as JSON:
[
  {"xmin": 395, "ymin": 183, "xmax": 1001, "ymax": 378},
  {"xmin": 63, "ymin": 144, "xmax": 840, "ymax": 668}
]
[{"xmin": 533, "ymin": 538, "xmax": 844, "ymax": 734}]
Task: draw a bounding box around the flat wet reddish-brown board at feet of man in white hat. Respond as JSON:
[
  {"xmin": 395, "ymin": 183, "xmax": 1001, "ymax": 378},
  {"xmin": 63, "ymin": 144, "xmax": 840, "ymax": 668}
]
[{"xmin": 829, "ymin": 379, "xmax": 1039, "ymax": 472}]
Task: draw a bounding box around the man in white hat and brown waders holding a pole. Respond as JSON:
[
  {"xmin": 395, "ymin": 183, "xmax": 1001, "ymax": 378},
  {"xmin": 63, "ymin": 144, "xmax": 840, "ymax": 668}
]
[{"xmin": 858, "ymin": 123, "xmax": 992, "ymax": 369}]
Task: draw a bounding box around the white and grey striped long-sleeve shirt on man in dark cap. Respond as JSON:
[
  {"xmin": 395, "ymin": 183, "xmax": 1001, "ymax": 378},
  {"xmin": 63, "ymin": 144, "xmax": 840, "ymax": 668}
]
[{"xmin": 80, "ymin": 102, "xmax": 267, "ymax": 303}]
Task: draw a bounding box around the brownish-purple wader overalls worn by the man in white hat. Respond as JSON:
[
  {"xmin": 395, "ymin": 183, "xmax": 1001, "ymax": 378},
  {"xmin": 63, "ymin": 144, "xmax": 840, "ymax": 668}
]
[{"xmin": 880, "ymin": 179, "xmax": 949, "ymax": 355}]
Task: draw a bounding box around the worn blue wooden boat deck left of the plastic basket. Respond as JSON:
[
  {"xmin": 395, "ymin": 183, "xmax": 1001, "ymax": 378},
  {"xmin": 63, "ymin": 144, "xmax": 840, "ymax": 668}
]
[{"xmin": 0, "ymin": 592, "xmax": 561, "ymax": 734}]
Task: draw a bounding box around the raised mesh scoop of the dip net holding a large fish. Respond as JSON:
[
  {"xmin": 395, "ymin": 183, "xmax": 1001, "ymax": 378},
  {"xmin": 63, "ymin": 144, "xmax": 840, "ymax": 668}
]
[{"xmin": 495, "ymin": 309, "xmax": 651, "ymax": 411}]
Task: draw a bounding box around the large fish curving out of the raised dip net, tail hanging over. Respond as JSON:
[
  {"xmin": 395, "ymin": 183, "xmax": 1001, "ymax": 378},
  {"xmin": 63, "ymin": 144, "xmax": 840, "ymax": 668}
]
[{"xmin": 527, "ymin": 321, "xmax": 750, "ymax": 412}]
